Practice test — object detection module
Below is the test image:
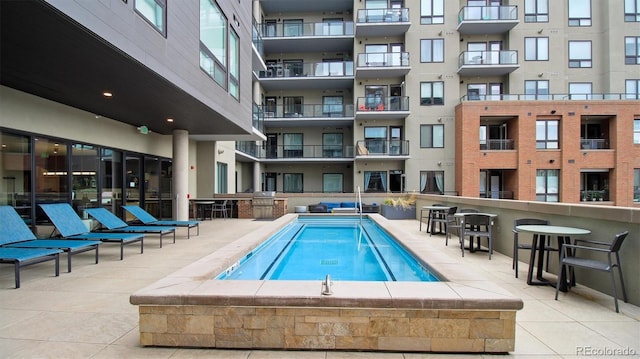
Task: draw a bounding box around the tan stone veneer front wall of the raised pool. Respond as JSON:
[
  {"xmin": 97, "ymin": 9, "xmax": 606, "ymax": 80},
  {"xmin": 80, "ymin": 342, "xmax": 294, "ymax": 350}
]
[{"xmin": 139, "ymin": 305, "xmax": 516, "ymax": 353}]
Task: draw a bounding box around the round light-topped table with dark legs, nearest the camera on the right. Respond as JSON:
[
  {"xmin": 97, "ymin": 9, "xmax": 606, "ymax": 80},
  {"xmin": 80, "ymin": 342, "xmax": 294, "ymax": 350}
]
[{"xmin": 516, "ymin": 225, "xmax": 591, "ymax": 292}]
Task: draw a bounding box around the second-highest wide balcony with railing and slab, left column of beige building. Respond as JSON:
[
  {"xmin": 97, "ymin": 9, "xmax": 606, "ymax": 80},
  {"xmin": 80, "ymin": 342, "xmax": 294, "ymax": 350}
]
[{"xmin": 258, "ymin": 61, "xmax": 354, "ymax": 90}]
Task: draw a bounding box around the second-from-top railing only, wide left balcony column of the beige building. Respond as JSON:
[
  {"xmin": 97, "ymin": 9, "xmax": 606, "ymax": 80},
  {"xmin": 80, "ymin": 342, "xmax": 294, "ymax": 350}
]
[{"xmin": 259, "ymin": 61, "xmax": 353, "ymax": 78}]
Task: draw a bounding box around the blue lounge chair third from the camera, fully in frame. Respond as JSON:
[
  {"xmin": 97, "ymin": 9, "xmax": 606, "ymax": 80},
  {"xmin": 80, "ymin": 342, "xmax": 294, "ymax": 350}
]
[{"xmin": 40, "ymin": 203, "xmax": 144, "ymax": 260}]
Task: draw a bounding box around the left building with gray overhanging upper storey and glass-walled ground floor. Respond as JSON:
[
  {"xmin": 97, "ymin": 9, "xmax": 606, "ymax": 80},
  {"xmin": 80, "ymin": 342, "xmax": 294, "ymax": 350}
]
[{"xmin": 0, "ymin": 0, "xmax": 265, "ymax": 227}]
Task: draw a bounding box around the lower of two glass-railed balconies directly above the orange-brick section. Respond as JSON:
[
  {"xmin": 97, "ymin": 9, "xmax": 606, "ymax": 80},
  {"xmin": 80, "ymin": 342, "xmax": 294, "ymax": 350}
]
[{"xmin": 458, "ymin": 50, "xmax": 520, "ymax": 76}]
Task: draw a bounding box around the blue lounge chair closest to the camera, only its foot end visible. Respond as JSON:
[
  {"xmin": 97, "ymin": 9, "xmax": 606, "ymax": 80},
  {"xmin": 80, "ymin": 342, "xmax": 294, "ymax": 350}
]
[{"xmin": 0, "ymin": 208, "xmax": 62, "ymax": 288}]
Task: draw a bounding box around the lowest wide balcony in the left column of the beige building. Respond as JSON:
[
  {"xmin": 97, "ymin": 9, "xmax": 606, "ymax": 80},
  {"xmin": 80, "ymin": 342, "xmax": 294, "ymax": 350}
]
[{"xmin": 257, "ymin": 145, "xmax": 353, "ymax": 163}]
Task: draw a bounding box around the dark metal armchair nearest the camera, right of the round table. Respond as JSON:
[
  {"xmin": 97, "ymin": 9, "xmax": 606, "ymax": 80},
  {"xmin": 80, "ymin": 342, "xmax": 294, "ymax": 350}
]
[{"xmin": 556, "ymin": 231, "xmax": 629, "ymax": 313}]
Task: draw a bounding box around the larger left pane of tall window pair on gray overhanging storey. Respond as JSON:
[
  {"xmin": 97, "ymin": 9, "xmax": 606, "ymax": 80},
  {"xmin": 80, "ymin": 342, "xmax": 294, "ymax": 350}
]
[{"xmin": 200, "ymin": 0, "xmax": 227, "ymax": 89}]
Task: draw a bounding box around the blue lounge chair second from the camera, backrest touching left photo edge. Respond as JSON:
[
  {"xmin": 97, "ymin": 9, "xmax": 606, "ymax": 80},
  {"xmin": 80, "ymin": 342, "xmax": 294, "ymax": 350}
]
[{"xmin": 0, "ymin": 206, "xmax": 100, "ymax": 272}]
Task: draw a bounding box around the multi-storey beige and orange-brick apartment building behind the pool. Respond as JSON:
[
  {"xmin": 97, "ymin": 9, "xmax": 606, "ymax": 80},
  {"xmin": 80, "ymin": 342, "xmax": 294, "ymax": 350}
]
[{"xmin": 241, "ymin": 0, "xmax": 640, "ymax": 206}]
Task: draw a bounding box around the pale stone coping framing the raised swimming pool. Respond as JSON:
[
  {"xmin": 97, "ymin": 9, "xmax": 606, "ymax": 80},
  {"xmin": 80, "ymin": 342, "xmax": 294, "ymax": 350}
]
[{"xmin": 130, "ymin": 214, "xmax": 523, "ymax": 311}]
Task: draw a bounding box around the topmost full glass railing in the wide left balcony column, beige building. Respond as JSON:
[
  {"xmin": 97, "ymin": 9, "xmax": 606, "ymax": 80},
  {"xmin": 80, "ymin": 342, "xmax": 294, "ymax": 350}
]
[{"xmin": 262, "ymin": 21, "xmax": 353, "ymax": 38}]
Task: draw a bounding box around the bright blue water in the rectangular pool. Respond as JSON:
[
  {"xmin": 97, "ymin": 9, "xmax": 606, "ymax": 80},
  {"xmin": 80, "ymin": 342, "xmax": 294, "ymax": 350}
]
[{"xmin": 216, "ymin": 216, "xmax": 439, "ymax": 281}]
